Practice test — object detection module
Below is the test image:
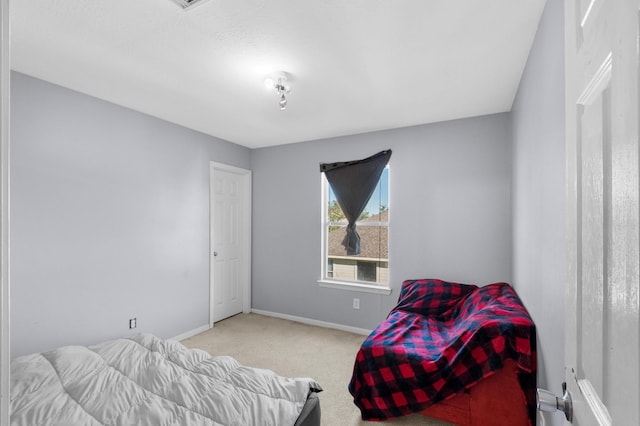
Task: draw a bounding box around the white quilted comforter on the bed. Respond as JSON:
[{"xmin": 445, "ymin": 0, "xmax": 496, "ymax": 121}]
[{"xmin": 11, "ymin": 334, "xmax": 320, "ymax": 426}]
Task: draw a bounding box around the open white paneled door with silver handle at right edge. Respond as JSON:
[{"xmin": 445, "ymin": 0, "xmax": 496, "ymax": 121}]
[{"xmin": 565, "ymin": 0, "xmax": 640, "ymax": 425}]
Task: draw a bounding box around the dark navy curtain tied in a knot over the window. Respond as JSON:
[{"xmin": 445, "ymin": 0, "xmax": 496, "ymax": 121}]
[{"xmin": 320, "ymin": 149, "xmax": 391, "ymax": 256}]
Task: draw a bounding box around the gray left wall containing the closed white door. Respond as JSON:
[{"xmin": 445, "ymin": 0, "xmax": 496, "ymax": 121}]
[{"xmin": 11, "ymin": 73, "xmax": 250, "ymax": 356}]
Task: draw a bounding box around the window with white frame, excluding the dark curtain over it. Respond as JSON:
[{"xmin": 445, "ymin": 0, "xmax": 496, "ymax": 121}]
[{"xmin": 322, "ymin": 166, "xmax": 389, "ymax": 288}]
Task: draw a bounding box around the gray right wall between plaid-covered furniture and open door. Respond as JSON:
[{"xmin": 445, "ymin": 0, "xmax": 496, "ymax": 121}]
[{"xmin": 512, "ymin": 0, "xmax": 566, "ymax": 425}]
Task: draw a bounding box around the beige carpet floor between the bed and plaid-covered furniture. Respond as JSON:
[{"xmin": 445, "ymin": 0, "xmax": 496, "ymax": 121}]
[{"xmin": 182, "ymin": 314, "xmax": 449, "ymax": 426}]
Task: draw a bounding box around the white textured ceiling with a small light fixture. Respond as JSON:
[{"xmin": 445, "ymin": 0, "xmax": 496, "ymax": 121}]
[{"xmin": 11, "ymin": 0, "xmax": 545, "ymax": 148}]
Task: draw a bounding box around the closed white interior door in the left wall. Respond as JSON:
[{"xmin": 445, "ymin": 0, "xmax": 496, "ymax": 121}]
[{"xmin": 210, "ymin": 163, "xmax": 251, "ymax": 325}]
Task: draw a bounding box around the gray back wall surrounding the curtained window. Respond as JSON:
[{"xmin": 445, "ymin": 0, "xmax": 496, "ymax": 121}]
[{"xmin": 251, "ymin": 114, "xmax": 512, "ymax": 329}]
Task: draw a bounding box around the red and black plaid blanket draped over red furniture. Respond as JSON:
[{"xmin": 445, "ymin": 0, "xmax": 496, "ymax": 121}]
[{"xmin": 349, "ymin": 279, "xmax": 536, "ymax": 424}]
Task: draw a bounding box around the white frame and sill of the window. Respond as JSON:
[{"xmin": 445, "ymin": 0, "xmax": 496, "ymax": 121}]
[{"xmin": 318, "ymin": 164, "xmax": 391, "ymax": 294}]
